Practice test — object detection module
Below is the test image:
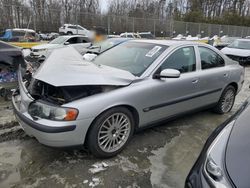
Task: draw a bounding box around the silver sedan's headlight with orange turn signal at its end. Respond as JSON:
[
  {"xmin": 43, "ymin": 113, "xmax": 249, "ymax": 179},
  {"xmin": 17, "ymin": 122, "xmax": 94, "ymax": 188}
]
[{"xmin": 28, "ymin": 102, "xmax": 78, "ymax": 121}]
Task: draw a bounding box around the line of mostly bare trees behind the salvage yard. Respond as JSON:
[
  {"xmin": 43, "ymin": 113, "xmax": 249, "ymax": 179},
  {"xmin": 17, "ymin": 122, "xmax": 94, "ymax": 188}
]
[{"xmin": 0, "ymin": 0, "xmax": 250, "ymax": 32}]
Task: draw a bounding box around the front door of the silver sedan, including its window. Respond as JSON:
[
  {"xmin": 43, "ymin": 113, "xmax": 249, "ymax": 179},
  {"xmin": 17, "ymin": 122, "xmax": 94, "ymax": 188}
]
[{"xmin": 141, "ymin": 46, "xmax": 202, "ymax": 125}]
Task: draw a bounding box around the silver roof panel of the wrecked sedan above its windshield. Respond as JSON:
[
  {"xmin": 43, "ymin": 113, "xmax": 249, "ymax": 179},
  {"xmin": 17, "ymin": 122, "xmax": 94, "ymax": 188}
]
[{"xmin": 133, "ymin": 39, "xmax": 203, "ymax": 46}]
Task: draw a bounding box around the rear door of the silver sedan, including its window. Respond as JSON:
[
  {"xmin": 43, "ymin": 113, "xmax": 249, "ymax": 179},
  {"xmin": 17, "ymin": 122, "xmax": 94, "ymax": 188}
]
[{"xmin": 195, "ymin": 46, "xmax": 229, "ymax": 104}]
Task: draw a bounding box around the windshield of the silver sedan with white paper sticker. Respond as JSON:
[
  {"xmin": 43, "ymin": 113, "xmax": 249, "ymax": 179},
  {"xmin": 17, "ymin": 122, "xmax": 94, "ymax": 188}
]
[{"xmin": 93, "ymin": 42, "xmax": 167, "ymax": 76}]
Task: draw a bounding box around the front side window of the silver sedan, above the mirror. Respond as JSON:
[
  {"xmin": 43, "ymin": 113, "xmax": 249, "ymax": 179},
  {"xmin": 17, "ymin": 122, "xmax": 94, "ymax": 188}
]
[{"xmin": 160, "ymin": 46, "xmax": 196, "ymax": 73}]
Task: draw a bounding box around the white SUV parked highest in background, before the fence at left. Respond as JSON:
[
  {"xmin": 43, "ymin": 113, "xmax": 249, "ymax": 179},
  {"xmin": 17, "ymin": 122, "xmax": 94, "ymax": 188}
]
[{"xmin": 59, "ymin": 24, "xmax": 94, "ymax": 39}]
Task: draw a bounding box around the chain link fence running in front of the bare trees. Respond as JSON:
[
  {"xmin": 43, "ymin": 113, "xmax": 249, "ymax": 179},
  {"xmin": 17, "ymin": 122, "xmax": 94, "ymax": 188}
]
[{"xmin": 0, "ymin": 5, "xmax": 250, "ymax": 37}]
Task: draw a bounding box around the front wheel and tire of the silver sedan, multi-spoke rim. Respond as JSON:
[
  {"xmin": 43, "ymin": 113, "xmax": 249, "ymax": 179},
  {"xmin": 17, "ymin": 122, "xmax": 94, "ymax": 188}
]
[{"xmin": 87, "ymin": 107, "xmax": 135, "ymax": 158}]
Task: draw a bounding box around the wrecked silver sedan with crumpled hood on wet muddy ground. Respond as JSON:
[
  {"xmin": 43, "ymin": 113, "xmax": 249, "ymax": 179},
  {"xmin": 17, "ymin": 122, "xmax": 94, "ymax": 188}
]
[{"xmin": 12, "ymin": 40, "xmax": 244, "ymax": 157}]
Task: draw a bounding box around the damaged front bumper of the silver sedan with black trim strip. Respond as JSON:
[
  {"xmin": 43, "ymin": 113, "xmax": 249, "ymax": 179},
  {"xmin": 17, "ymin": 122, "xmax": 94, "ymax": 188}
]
[{"xmin": 12, "ymin": 69, "xmax": 93, "ymax": 147}]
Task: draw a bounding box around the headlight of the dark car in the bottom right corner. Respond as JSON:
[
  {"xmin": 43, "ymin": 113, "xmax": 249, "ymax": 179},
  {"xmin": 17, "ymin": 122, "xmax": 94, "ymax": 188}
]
[{"xmin": 204, "ymin": 121, "xmax": 235, "ymax": 188}]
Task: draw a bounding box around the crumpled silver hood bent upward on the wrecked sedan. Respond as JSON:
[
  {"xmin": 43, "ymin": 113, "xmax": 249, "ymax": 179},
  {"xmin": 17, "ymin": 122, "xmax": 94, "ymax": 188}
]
[{"xmin": 33, "ymin": 46, "xmax": 136, "ymax": 87}]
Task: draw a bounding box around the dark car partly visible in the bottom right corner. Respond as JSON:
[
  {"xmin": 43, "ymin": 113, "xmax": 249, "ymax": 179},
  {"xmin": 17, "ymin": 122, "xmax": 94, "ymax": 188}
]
[{"xmin": 185, "ymin": 100, "xmax": 250, "ymax": 188}]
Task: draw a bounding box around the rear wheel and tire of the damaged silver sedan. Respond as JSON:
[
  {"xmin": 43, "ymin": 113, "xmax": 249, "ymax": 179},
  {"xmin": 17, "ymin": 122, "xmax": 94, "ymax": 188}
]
[{"xmin": 213, "ymin": 85, "xmax": 236, "ymax": 114}]
